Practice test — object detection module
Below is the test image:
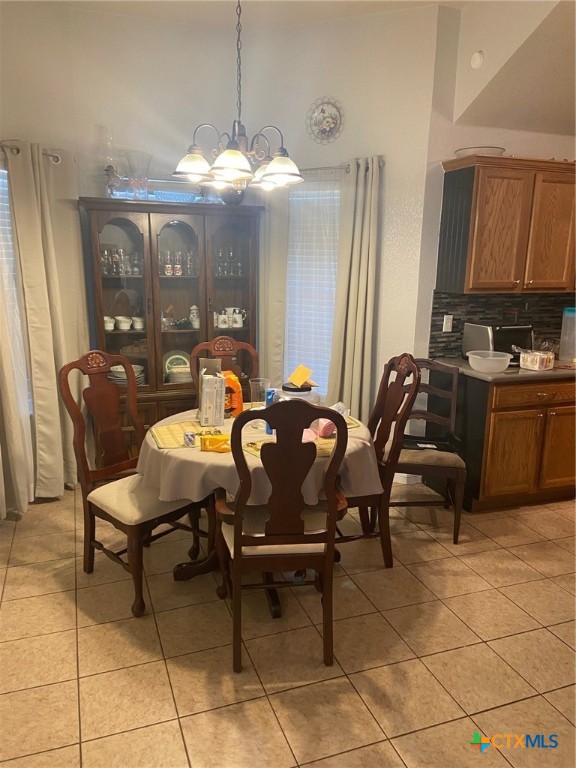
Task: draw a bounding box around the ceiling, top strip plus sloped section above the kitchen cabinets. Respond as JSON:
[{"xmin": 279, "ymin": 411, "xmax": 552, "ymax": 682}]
[{"xmin": 66, "ymin": 0, "xmax": 576, "ymax": 136}]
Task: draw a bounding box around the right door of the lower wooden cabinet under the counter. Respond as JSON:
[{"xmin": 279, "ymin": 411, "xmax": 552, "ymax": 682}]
[{"xmin": 539, "ymin": 405, "xmax": 576, "ymax": 488}]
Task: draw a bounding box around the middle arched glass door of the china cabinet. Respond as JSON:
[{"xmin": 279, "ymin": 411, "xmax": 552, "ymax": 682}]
[{"xmin": 150, "ymin": 213, "xmax": 207, "ymax": 390}]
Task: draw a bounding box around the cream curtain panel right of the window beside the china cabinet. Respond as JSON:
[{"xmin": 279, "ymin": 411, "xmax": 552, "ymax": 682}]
[{"xmin": 327, "ymin": 156, "xmax": 384, "ymax": 422}]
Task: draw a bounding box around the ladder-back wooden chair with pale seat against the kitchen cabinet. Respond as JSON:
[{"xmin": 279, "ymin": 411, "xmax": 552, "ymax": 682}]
[{"xmin": 393, "ymin": 358, "xmax": 466, "ymax": 544}]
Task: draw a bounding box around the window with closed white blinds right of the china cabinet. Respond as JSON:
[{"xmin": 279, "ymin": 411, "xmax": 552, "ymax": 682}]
[{"xmin": 284, "ymin": 169, "xmax": 340, "ymax": 396}]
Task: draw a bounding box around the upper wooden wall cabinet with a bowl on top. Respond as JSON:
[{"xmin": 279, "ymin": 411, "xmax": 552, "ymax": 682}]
[{"xmin": 436, "ymin": 155, "xmax": 575, "ymax": 293}]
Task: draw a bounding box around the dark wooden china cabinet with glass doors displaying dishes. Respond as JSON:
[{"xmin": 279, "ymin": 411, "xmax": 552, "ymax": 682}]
[{"xmin": 79, "ymin": 198, "xmax": 262, "ymax": 425}]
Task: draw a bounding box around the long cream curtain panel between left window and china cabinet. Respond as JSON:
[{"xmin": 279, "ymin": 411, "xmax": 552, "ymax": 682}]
[{"xmin": 6, "ymin": 142, "xmax": 89, "ymax": 498}]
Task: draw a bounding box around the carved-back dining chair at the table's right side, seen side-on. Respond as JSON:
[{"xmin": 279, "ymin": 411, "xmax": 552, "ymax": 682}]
[{"xmin": 336, "ymin": 353, "xmax": 420, "ymax": 568}]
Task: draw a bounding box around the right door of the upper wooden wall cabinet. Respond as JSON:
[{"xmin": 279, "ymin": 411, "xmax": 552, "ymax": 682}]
[{"xmin": 524, "ymin": 172, "xmax": 574, "ymax": 291}]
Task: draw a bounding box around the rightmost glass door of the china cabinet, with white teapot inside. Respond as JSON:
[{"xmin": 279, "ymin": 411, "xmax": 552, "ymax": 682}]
[{"xmin": 206, "ymin": 210, "xmax": 258, "ymax": 345}]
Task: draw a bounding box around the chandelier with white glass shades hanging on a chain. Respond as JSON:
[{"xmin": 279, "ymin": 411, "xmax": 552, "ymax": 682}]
[{"xmin": 172, "ymin": 0, "xmax": 303, "ymax": 191}]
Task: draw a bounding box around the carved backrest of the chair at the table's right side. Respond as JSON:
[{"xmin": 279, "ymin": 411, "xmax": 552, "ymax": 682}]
[{"xmin": 368, "ymin": 352, "xmax": 420, "ymax": 475}]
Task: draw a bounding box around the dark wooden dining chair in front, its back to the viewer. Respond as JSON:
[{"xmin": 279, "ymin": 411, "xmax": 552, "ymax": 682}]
[{"xmin": 216, "ymin": 400, "xmax": 348, "ymax": 672}]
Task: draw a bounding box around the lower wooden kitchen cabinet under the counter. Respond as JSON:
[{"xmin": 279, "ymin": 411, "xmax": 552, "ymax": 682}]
[{"xmin": 457, "ymin": 376, "xmax": 576, "ymax": 511}]
